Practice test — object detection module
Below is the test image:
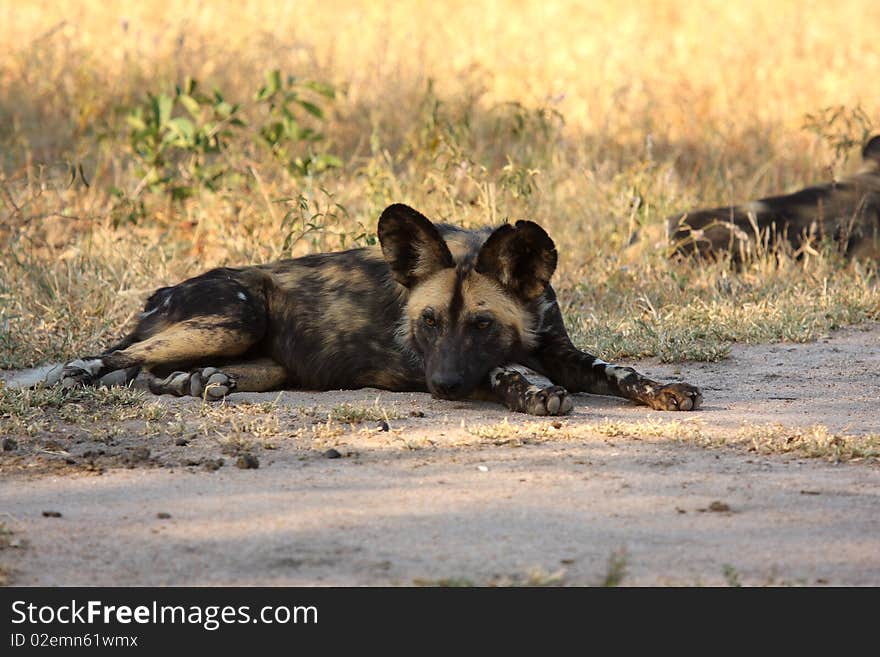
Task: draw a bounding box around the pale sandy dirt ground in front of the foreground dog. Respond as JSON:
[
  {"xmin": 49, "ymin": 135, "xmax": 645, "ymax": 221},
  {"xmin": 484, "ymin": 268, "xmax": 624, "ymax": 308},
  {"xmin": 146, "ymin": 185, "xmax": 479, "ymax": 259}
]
[{"xmin": 0, "ymin": 324, "xmax": 880, "ymax": 586}]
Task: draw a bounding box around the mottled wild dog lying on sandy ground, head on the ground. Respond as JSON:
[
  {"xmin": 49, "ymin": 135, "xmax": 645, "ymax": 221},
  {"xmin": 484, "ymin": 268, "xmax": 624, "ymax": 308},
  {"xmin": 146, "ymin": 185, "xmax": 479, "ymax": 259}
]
[{"xmin": 61, "ymin": 204, "xmax": 701, "ymax": 415}]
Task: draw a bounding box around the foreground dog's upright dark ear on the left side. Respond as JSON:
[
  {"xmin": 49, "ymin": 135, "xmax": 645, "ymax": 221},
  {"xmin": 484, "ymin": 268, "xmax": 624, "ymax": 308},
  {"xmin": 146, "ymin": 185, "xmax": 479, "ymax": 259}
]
[{"xmin": 377, "ymin": 203, "xmax": 455, "ymax": 288}]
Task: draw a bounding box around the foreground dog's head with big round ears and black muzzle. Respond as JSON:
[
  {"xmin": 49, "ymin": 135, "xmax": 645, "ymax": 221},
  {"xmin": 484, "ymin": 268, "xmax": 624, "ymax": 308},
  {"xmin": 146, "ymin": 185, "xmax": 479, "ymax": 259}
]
[{"xmin": 378, "ymin": 204, "xmax": 556, "ymax": 399}]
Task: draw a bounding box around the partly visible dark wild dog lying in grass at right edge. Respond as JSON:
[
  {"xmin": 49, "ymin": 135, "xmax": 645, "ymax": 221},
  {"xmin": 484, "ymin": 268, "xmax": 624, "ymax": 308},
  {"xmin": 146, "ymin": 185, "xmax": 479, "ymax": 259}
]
[{"xmin": 667, "ymin": 135, "xmax": 880, "ymax": 262}]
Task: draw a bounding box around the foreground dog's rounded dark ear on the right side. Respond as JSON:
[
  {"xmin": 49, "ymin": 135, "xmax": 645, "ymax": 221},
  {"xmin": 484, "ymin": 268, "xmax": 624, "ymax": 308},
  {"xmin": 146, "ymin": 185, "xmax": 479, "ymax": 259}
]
[{"xmin": 475, "ymin": 221, "xmax": 557, "ymax": 301}]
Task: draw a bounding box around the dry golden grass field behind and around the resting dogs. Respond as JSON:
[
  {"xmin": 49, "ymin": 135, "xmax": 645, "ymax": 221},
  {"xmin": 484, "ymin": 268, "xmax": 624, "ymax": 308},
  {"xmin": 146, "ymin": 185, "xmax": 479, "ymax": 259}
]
[{"xmin": 0, "ymin": 0, "xmax": 880, "ymax": 367}]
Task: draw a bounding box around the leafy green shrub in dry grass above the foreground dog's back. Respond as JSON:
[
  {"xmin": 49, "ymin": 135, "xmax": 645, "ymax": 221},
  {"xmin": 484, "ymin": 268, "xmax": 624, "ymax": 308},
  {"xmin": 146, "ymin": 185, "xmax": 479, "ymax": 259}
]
[{"xmin": 117, "ymin": 69, "xmax": 341, "ymax": 206}]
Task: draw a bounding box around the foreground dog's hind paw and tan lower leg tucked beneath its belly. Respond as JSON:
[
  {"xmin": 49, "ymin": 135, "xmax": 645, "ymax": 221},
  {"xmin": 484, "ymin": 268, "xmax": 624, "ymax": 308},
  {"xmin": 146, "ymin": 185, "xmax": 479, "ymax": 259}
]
[{"xmin": 150, "ymin": 358, "xmax": 287, "ymax": 401}]
